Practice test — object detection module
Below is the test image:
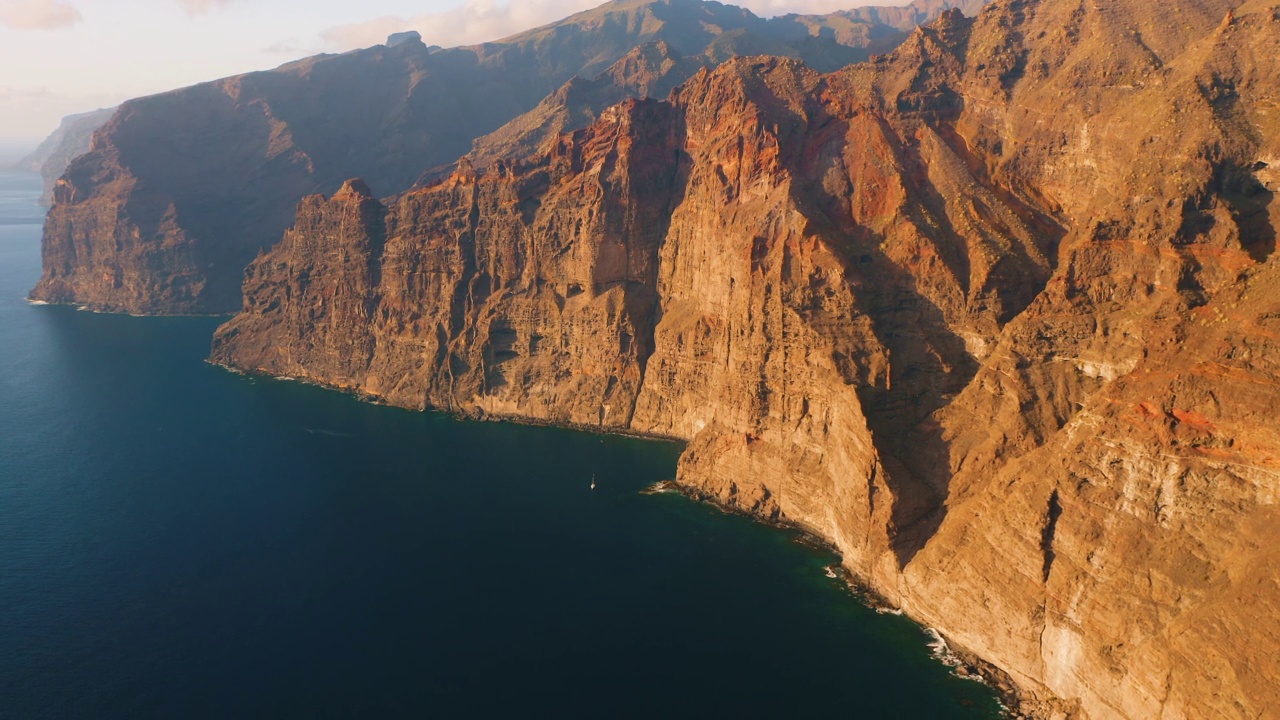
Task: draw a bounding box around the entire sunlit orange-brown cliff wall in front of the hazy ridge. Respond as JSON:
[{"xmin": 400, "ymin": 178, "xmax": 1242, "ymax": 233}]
[{"xmin": 214, "ymin": 0, "xmax": 1280, "ymax": 719}]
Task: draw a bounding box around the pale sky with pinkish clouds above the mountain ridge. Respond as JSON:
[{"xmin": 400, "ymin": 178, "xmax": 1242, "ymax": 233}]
[{"xmin": 0, "ymin": 0, "xmax": 904, "ymax": 147}]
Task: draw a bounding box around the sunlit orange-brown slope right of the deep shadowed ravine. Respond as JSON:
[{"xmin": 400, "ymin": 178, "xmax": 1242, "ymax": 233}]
[{"xmin": 880, "ymin": 3, "xmax": 1280, "ymax": 717}]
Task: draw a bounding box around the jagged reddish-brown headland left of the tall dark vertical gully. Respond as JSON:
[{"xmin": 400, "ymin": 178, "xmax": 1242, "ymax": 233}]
[{"xmin": 219, "ymin": 101, "xmax": 677, "ymax": 415}]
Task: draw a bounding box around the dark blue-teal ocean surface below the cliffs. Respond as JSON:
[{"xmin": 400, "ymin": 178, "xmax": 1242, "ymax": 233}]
[{"xmin": 0, "ymin": 167, "xmax": 1000, "ymax": 719}]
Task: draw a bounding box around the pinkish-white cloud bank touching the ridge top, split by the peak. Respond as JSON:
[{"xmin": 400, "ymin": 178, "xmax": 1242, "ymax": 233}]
[{"xmin": 320, "ymin": 0, "xmax": 906, "ymax": 50}]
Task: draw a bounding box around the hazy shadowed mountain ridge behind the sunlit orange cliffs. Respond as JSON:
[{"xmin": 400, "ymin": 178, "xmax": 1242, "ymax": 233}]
[{"xmin": 32, "ymin": 0, "xmax": 988, "ymax": 314}]
